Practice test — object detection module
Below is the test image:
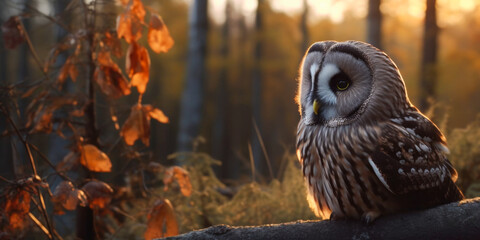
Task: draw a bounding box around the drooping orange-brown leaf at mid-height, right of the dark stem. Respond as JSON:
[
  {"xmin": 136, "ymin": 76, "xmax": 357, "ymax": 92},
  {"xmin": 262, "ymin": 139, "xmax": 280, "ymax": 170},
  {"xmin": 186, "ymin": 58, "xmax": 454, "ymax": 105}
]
[{"xmin": 120, "ymin": 104, "xmax": 150, "ymax": 146}]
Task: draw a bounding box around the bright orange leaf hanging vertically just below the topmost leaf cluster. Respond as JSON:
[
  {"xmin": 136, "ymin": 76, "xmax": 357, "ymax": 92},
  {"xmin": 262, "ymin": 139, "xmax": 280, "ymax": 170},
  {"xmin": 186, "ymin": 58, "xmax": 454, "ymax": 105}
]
[{"xmin": 125, "ymin": 42, "xmax": 150, "ymax": 94}]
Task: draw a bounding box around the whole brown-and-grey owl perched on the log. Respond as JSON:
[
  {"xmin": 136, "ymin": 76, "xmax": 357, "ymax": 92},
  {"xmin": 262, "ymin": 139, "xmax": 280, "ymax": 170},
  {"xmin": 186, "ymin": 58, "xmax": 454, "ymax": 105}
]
[{"xmin": 296, "ymin": 41, "xmax": 463, "ymax": 223}]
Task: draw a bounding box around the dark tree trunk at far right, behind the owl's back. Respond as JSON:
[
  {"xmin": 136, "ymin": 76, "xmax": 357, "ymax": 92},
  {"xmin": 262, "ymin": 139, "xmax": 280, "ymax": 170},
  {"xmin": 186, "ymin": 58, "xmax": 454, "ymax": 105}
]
[{"xmin": 419, "ymin": 0, "xmax": 438, "ymax": 111}]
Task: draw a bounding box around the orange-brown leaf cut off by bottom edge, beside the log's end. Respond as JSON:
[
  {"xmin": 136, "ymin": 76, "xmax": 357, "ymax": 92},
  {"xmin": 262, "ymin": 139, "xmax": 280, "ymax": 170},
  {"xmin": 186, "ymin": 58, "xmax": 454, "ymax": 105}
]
[{"xmin": 143, "ymin": 199, "xmax": 178, "ymax": 240}]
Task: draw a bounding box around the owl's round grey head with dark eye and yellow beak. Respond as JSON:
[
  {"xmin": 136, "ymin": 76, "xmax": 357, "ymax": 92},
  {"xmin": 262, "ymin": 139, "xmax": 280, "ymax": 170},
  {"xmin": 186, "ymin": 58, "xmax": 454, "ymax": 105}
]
[{"xmin": 297, "ymin": 41, "xmax": 411, "ymax": 127}]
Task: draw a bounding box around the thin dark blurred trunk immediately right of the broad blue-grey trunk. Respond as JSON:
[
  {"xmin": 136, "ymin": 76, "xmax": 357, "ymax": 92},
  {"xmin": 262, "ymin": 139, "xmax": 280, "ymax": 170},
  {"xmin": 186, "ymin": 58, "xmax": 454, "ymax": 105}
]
[{"xmin": 212, "ymin": 0, "xmax": 232, "ymax": 178}]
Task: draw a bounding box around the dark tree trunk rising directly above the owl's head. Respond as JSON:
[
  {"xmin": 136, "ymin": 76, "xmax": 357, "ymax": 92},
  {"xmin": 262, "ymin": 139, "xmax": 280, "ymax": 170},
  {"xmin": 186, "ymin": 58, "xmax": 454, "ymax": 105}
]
[{"xmin": 367, "ymin": 0, "xmax": 382, "ymax": 49}]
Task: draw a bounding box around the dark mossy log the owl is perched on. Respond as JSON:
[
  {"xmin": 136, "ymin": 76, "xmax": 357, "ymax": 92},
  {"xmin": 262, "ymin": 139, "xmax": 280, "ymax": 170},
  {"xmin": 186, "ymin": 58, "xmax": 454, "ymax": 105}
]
[{"xmin": 162, "ymin": 197, "xmax": 480, "ymax": 240}]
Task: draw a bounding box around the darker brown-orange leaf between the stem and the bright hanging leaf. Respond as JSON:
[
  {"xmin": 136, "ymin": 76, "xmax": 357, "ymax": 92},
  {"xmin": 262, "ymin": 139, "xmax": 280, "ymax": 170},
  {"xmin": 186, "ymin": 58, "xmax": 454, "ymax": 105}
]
[{"xmin": 93, "ymin": 52, "xmax": 130, "ymax": 98}]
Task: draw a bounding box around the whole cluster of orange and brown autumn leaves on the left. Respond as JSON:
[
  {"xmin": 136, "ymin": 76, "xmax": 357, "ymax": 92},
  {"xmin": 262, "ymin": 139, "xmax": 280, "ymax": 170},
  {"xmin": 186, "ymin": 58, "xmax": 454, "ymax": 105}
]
[{"xmin": 0, "ymin": 0, "xmax": 186, "ymax": 239}]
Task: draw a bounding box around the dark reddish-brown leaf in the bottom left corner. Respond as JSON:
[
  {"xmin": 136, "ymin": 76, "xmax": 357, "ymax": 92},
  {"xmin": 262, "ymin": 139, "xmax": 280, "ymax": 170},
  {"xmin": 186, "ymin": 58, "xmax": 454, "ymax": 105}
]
[{"xmin": 3, "ymin": 189, "xmax": 30, "ymax": 231}]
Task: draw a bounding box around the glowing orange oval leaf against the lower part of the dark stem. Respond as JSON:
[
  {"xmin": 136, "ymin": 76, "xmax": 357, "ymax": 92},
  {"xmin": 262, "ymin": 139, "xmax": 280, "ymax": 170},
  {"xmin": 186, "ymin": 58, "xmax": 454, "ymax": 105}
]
[{"xmin": 80, "ymin": 144, "xmax": 112, "ymax": 172}]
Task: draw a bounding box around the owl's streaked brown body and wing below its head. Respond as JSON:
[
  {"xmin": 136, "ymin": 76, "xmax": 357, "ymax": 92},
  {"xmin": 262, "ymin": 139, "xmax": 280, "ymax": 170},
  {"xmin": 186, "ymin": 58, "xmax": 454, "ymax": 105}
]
[{"xmin": 297, "ymin": 109, "xmax": 463, "ymax": 219}]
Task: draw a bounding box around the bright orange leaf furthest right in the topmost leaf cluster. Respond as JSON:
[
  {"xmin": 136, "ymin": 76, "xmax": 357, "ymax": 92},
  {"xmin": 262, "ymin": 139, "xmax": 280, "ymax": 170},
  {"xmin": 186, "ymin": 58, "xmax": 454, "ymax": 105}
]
[{"xmin": 148, "ymin": 14, "xmax": 174, "ymax": 53}]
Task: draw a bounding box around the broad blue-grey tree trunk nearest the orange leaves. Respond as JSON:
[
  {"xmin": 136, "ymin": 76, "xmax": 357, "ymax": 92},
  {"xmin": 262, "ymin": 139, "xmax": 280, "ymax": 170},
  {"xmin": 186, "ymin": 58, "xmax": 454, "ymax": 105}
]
[{"xmin": 177, "ymin": 0, "xmax": 208, "ymax": 151}]
